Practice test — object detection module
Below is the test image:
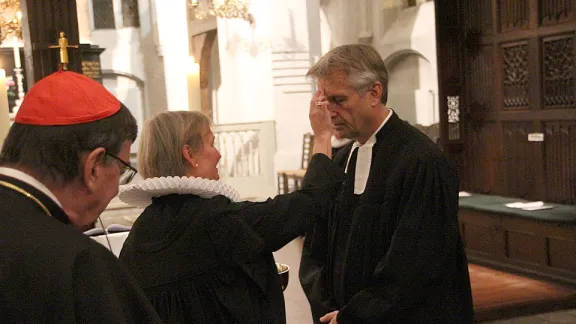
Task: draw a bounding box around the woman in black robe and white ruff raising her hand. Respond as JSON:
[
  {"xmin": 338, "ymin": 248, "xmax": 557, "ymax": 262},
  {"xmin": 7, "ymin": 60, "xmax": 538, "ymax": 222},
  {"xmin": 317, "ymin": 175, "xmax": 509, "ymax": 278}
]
[{"xmin": 120, "ymin": 105, "xmax": 343, "ymax": 323}]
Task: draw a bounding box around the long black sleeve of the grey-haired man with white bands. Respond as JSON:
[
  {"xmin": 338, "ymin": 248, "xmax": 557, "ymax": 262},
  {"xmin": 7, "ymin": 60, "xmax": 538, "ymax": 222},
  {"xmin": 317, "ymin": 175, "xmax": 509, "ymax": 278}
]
[{"xmin": 337, "ymin": 157, "xmax": 459, "ymax": 324}]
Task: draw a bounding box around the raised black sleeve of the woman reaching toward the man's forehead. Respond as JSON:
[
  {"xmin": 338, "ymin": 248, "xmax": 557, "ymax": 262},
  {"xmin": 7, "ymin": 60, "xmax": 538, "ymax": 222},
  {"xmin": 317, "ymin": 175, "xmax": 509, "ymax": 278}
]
[{"xmin": 233, "ymin": 154, "xmax": 344, "ymax": 251}]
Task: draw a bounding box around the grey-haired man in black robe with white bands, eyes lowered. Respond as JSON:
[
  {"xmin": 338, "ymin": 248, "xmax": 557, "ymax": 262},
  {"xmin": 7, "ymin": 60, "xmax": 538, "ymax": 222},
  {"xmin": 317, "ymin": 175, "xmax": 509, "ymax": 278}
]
[{"xmin": 299, "ymin": 45, "xmax": 474, "ymax": 324}]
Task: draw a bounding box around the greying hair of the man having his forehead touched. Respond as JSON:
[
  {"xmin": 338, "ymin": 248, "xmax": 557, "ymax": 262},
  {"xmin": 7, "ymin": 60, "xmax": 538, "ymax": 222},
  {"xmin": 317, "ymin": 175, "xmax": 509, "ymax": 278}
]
[{"xmin": 306, "ymin": 44, "xmax": 388, "ymax": 104}]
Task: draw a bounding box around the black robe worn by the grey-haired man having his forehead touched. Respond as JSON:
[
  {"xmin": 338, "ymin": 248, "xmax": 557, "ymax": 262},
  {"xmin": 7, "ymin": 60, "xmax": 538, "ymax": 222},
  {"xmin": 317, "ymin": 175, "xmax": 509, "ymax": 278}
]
[{"xmin": 299, "ymin": 114, "xmax": 474, "ymax": 324}]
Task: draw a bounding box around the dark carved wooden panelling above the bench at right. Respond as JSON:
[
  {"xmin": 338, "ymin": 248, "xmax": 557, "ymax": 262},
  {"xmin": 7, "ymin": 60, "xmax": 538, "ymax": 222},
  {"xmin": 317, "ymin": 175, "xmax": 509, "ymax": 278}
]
[{"xmin": 436, "ymin": 0, "xmax": 576, "ymax": 204}]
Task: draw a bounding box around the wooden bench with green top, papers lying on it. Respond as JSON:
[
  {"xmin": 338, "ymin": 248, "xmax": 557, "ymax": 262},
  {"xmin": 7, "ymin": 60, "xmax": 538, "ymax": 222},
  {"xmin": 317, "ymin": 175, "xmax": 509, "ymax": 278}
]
[{"xmin": 459, "ymin": 194, "xmax": 576, "ymax": 283}]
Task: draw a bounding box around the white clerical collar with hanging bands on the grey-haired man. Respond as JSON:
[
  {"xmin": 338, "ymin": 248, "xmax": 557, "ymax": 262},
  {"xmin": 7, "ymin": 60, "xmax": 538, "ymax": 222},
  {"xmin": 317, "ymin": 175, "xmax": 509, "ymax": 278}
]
[{"xmin": 346, "ymin": 109, "xmax": 394, "ymax": 195}]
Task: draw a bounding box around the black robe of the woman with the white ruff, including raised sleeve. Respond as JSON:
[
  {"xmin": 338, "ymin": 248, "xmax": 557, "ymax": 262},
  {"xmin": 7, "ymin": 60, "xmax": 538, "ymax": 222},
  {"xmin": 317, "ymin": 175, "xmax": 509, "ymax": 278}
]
[{"xmin": 120, "ymin": 154, "xmax": 343, "ymax": 324}]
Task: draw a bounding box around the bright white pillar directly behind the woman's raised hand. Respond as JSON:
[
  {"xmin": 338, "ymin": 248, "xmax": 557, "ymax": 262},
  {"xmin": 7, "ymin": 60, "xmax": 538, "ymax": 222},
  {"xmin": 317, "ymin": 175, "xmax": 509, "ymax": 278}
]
[{"xmin": 271, "ymin": 0, "xmax": 321, "ymax": 170}]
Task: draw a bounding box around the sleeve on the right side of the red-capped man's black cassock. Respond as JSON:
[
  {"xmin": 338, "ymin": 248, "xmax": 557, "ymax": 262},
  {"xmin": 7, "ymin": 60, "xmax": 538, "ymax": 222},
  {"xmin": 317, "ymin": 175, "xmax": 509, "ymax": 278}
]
[{"xmin": 72, "ymin": 243, "xmax": 161, "ymax": 323}]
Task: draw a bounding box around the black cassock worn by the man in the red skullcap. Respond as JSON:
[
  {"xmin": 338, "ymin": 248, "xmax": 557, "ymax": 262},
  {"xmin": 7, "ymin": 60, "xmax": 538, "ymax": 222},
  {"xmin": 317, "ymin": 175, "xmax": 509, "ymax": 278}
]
[{"xmin": 0, "ymin": 175, "xmax": 160, "ymax": 323}]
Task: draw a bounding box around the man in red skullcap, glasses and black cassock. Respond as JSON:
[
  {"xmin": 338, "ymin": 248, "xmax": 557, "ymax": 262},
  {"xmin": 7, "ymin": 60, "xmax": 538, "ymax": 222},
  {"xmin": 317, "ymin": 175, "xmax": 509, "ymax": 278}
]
[{"xmin": 0, "ymin": 71, "xmax": 160, "ymax": 323}]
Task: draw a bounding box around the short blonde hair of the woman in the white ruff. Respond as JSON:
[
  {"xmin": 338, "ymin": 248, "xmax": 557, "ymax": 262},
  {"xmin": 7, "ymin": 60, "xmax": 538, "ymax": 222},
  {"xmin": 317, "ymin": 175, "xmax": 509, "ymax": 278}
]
[{"xmin": 138, "ymin": 111, "xmax": 211, "ymax": 179}]
